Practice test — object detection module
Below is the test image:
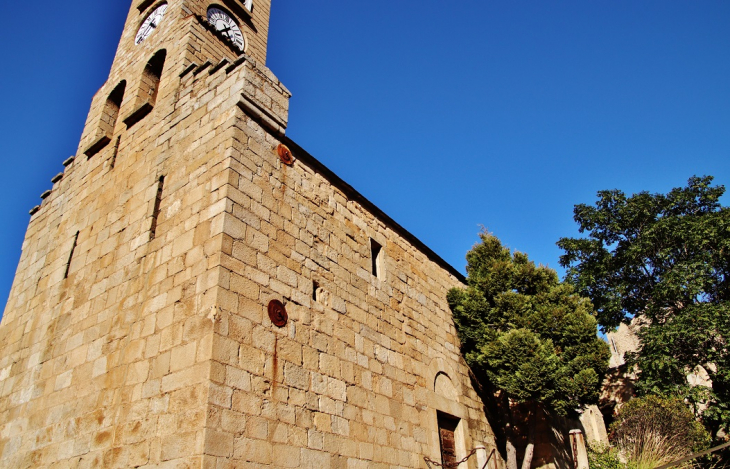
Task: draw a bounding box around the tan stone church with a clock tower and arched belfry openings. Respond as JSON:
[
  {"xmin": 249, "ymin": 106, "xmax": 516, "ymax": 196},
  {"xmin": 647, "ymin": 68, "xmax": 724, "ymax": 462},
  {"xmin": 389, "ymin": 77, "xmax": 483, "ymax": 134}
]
[{"xmin": 0, "ymin": 0, "xmax": 503, "ymax": 469}]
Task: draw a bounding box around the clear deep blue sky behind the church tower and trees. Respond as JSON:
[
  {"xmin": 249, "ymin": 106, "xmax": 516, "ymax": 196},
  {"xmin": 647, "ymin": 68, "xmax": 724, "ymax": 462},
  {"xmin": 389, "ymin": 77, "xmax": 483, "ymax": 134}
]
[{"xmin": 0, "ymin": 0, "xmax": 730, "ymax": 314}]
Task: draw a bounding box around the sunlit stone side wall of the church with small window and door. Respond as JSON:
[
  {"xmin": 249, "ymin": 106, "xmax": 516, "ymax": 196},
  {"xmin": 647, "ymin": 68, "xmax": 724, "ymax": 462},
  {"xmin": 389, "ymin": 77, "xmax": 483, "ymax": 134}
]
[{"xmin": 191, "ymin": 60, "xmax": 496, "ymax": 468}]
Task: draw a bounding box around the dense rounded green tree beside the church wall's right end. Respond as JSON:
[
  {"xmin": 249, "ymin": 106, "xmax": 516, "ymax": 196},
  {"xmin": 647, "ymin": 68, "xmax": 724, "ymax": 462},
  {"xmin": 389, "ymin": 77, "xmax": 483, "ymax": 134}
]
[{"xmin": 448, "ymin": 233, "xmax": 609, "ymax": 469}]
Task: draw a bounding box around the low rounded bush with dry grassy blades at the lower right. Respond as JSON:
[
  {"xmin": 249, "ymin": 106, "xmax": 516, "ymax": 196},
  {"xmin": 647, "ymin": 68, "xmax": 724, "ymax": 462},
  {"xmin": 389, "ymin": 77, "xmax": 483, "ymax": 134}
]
[{"xmin": 611, "ymin": 396, "xmax": 711, "ymax": 469}]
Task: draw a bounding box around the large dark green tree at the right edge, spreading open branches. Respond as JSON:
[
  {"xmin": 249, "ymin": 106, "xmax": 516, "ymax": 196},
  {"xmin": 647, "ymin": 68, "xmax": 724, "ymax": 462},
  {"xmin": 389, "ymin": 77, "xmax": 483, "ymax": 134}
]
[{"xmin": 558, "ymin": 176, "xmax": 730, "ymax": 431}]
